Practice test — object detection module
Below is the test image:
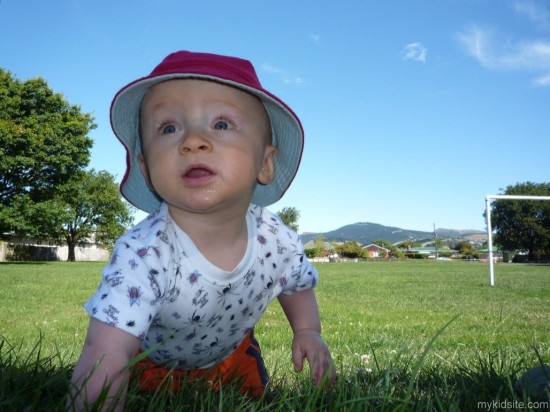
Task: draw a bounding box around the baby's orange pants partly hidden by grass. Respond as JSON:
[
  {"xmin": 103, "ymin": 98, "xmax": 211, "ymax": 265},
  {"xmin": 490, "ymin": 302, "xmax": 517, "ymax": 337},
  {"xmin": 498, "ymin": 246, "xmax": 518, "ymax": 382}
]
[{"xmin": 130, "ymin": 332, "xmax": 268, "ymax": 397}]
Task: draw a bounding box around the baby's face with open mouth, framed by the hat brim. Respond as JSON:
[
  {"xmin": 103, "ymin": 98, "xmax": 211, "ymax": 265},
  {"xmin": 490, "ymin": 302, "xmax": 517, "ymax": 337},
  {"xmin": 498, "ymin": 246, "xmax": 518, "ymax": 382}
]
[{"xmin": 140, "ymin": 79, "xmax": 276, "ymax": 215}]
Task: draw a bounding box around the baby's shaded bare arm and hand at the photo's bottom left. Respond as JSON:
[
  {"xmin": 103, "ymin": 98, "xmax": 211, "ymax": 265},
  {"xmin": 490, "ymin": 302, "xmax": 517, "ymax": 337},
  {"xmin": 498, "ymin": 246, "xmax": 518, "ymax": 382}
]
[{"xmin": 67, "ymin": 318, "xmax": 139, "ymax": 411}]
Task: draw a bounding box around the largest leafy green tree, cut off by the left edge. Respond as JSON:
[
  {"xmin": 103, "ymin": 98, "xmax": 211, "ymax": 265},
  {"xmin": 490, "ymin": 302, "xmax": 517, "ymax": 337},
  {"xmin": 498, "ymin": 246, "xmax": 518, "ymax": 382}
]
[{"xmin": 0, "ymin": 69, "xmax": 96, "ymax": 237}]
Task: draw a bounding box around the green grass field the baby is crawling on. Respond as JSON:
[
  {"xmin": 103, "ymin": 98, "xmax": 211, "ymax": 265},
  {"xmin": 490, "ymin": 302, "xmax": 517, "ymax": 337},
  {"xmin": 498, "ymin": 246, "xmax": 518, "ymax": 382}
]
[{"xmin": 0, "ymin": 261, "xmax": 550, "ymax": 411}]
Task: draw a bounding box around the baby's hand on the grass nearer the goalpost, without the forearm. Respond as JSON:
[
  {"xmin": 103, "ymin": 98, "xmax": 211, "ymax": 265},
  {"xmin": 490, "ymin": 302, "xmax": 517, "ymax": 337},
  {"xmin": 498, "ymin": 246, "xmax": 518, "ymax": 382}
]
[{"xmin": 292, "ymin": 329, "xmax": 336, "ymax": 386}]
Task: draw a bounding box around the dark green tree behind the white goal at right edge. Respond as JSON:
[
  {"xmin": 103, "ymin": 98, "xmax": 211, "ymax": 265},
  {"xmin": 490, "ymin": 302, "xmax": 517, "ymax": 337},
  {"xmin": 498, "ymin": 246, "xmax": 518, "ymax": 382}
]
[{"xmin": 491, "ymin": 182, "xmax": 550, "ymax": 261}]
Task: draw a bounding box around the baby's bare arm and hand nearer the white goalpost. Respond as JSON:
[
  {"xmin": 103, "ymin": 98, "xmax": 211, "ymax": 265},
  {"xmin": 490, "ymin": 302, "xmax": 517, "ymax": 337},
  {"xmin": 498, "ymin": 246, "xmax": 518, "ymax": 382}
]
[{"xmin": 279, "ymin": 289, "xmax": 336, "ymax": 384}]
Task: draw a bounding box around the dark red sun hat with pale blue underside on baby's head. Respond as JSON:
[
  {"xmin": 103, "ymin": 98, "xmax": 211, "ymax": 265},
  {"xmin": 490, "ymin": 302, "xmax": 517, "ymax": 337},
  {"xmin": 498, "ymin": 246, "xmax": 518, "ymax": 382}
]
[{"xmin": 111, "ymin": 51, "xmax": 304, "ymax": 213}]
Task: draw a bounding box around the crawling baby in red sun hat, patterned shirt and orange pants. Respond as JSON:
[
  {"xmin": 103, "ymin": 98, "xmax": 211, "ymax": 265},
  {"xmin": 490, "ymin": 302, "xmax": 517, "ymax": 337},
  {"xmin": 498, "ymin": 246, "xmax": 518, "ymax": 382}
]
[{"xmin": 68, "ymin": 51, "xmax": 336, "ymax": 410}]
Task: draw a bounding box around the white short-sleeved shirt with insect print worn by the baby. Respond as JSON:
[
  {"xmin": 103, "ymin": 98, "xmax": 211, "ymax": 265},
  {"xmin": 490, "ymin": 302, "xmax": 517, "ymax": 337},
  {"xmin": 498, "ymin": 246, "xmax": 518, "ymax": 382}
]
[{"xmin": 84, "ymin": 203, "xmax": 318, "ymax": 370}]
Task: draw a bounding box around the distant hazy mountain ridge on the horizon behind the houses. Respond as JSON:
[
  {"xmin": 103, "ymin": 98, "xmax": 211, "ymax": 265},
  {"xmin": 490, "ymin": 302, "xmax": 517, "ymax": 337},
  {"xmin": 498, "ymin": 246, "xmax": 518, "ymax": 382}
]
[{"xmin": 301, "ymin": 222, "xmax": 485, "ymax": 245}]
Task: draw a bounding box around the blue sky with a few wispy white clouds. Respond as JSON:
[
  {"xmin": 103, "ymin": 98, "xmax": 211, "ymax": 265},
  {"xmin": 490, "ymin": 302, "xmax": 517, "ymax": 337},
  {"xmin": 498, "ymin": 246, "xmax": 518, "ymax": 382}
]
[{"xmin": 0, "ymin": 0, "xmax": 550, "ymax": 232}]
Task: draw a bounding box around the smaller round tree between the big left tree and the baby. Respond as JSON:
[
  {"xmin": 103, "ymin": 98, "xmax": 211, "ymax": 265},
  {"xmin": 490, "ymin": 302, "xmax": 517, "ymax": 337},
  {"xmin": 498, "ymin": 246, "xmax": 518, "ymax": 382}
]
[{"xmin": 48, "ymin": 170, "xmax": 133, "ymax": 262}]
